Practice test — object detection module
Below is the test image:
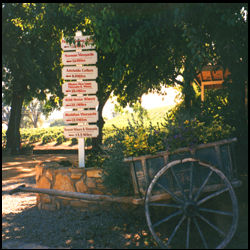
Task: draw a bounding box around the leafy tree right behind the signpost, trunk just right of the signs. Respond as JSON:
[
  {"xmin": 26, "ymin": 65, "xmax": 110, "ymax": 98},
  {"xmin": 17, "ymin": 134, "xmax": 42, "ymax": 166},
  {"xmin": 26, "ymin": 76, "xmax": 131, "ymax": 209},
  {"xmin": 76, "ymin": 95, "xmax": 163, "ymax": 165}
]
[{"xmin": 55, "ymin": 3, "xmax": 188, "ymax": 149}]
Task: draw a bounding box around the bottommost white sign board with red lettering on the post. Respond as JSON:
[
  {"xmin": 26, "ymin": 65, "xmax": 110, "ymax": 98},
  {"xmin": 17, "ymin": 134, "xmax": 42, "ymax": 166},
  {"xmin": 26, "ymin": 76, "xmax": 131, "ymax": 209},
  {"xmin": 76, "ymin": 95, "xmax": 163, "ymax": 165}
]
[{"xmin": 64, "ymin": 125, "xmax": 99, "ymax": 138}]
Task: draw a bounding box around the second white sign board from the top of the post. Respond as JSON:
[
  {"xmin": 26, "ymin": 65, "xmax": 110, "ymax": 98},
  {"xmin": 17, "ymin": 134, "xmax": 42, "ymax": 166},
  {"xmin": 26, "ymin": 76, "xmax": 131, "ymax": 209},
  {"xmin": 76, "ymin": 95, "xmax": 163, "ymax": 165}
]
[{"xmin": 62, "ymin": 50, "xmax": 97, "ymax": 65}]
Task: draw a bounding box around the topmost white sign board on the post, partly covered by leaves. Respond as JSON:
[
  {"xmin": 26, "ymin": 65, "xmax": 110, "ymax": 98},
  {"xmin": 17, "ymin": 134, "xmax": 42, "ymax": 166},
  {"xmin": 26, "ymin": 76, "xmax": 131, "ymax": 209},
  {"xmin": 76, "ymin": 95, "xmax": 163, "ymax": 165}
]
[{"xmin": 61, "ymin": 36, "xmax": 95, "ymax": 51}]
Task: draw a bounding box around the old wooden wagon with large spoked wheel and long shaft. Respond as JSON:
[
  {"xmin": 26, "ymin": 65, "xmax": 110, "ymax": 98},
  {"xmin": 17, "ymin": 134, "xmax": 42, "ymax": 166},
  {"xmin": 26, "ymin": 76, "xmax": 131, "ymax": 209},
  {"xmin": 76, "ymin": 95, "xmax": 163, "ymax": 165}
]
[{"xmin": 11, "ymin": 138, "xmax": 241, "ymax": 249}]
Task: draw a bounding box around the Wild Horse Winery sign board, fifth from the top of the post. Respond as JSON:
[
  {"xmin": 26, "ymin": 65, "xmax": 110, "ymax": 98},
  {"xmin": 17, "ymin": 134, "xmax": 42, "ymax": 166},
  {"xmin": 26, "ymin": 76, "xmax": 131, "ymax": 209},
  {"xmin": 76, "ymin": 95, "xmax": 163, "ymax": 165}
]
[{"xmin": 63, "ymin": 96, "xmax": 99, "ymax": 109}]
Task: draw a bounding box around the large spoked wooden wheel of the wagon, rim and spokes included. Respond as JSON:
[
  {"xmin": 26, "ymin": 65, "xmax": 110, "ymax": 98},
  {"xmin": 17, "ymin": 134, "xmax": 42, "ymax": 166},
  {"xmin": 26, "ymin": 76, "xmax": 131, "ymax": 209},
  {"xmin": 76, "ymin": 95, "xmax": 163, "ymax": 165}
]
[{"xmin": 145, "ymin": 158, "xmax": 238, "ymax": 249}]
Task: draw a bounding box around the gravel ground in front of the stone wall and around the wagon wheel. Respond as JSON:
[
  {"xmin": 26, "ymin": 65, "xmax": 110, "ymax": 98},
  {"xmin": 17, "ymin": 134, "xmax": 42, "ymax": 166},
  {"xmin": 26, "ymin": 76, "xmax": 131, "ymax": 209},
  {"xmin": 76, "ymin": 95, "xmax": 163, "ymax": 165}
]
[{"xmin": 2, "ymin": 153, "xmax": 248, "ymax": 249}]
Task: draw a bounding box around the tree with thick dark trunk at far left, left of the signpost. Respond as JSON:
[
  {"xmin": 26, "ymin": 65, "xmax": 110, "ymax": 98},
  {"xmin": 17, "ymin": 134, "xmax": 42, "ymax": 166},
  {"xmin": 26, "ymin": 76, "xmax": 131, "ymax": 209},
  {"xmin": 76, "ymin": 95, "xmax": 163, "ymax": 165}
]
[{"xmin": 2, "ymin": 3, "xmax": 62, "ymax": 153}]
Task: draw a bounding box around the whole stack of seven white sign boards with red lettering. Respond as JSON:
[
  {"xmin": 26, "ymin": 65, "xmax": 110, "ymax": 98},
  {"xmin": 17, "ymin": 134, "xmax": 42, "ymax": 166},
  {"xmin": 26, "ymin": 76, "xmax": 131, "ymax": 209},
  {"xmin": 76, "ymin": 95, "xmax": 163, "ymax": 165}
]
[{"xmin": 61, "ymin": 36, "xmax": 99, "ymax": 138}]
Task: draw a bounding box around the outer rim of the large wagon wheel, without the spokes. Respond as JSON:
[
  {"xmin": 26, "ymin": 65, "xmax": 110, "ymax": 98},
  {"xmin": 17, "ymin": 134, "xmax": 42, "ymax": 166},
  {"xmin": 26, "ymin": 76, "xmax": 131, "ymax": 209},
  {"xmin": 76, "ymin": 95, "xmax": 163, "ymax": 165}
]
[{"xmin": 145, "ymin": 158, "xmax": 238, "ymax": 249}]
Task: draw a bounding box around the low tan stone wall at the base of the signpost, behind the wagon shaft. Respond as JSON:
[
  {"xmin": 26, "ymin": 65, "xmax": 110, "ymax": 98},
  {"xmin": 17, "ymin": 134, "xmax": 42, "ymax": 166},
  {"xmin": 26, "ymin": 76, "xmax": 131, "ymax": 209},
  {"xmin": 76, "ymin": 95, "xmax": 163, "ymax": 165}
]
[{"xmin": 36, "ymin": 162, "xmax": 111, "ymax": 210}]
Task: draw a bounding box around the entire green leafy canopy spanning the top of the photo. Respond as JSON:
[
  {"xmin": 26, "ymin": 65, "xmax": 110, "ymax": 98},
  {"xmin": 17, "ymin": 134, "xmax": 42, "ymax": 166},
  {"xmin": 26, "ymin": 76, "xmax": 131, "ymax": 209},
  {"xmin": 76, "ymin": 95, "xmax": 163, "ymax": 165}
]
[{"xmin": 2, "ymin": 3, "xmax": 247, "ymax": 156}]
